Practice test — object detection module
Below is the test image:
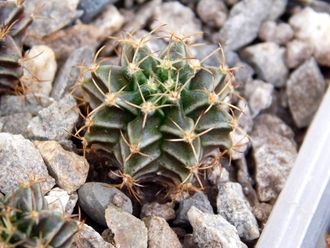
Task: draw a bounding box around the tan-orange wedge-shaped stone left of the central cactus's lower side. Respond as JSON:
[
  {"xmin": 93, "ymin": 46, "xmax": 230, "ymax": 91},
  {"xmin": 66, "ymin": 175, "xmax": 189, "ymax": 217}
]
[{"xmin": 34, "ymin": 141, "xmax": 89, "ymax": 193}]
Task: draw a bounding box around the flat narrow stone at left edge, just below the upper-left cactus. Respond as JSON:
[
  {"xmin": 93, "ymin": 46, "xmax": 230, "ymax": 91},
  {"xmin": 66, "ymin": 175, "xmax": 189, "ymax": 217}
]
[{"xmin": 0, "ymin": 94, "xmax": 54, "ymax": 116}]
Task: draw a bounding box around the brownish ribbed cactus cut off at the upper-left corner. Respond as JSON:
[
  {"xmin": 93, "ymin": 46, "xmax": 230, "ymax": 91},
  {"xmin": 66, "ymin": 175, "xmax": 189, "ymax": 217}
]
[{"xmin": 0, "ymin": 1, "xmax": 32, "ymax": 93}]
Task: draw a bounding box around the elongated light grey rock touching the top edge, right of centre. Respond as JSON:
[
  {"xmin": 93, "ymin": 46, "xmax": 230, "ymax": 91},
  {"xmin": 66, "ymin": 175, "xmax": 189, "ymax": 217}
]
[{"xmin": 215, "ymin": 0, "xmax": 272, "ymax": 50}]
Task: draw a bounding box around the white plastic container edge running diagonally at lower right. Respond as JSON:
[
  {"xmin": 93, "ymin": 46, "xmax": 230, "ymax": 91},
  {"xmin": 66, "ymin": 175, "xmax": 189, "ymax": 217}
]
[{"xmin": 256, "ymin": 87, "xmax": 330, "ymax": 248}]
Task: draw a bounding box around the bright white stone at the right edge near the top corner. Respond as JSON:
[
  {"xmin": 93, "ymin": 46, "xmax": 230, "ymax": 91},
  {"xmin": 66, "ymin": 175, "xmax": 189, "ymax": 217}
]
[{"xmin": 289, "ymin": 7, "xmax": 330, "ymax": 66}]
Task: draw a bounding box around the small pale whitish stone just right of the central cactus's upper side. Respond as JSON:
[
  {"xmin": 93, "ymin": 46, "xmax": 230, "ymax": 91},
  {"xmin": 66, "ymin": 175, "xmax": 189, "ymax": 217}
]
[{"xmin": 245, "ymin": 80, "xmax": 274, "ymax": 117}]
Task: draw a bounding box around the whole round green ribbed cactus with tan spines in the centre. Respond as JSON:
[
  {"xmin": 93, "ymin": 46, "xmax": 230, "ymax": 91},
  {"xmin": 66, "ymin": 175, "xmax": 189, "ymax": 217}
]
[{"xmin": 82, "ymin": 32, "xmax": 235, "ymax": 196}]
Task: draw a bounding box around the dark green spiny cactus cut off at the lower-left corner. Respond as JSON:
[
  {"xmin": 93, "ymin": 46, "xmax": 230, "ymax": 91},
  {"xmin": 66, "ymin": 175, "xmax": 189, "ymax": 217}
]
[{"xmin": 0, "ymin": 184, "xmax": 78, "ymax": 248}]
